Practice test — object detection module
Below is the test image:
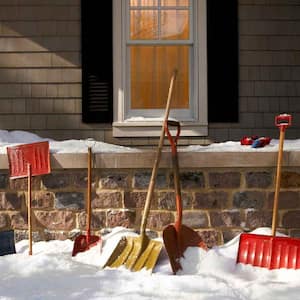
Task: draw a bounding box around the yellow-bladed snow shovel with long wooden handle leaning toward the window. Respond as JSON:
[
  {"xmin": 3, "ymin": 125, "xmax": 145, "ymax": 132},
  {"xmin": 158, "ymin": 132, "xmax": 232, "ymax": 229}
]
[{"xmin": 104, "ymin": 70, "xmax": 177, "ymax": 271}]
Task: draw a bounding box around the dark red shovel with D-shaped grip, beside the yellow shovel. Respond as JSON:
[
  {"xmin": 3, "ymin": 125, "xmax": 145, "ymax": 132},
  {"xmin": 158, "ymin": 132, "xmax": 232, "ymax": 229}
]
[{"xmin": 163, "ymin": 120, "xmax": 207, "ymax": 274}]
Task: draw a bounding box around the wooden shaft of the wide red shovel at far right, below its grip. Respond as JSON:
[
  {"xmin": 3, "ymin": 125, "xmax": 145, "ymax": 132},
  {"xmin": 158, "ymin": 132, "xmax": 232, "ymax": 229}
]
[{"xmin": 272, "ymin": 129, "xmax": 285, "ymax": 236}]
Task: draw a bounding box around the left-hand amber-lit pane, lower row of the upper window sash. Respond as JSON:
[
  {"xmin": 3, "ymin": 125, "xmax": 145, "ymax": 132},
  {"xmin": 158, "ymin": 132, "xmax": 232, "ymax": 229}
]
[{"xmin": 130, "ymin": 10, "xmax": 158, "ymax": 40}]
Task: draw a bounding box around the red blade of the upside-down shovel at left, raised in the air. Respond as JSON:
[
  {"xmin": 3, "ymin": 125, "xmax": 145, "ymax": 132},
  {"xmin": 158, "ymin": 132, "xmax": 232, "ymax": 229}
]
[{"xmin": 7, "ymin": 141, "xmax": 51, "ymax": 178}]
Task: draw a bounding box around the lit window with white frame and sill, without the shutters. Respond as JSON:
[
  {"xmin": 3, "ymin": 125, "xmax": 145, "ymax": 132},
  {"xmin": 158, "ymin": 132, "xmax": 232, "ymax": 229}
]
[{"xmin": 113, "ymin": 0, "xmax": 207, "ymax": 136}]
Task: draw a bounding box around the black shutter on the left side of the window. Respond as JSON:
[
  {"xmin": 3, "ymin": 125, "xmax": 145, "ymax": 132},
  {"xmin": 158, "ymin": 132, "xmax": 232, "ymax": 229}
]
[{"xmin": 81, "ymin": 0, "xmax": 113, "ymax": 123}]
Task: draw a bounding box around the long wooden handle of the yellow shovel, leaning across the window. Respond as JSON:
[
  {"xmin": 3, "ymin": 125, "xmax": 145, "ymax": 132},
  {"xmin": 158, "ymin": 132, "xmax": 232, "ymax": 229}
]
[{"xmin": 140, "ymin": 70, "xmax": 177, "ymax": 235}]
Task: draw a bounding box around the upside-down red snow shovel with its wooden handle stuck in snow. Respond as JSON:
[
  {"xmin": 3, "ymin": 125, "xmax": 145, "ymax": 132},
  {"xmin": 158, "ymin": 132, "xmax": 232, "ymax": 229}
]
[{"xmin": 7, "ymin": 141, "xmax": 51, "ymax": 255}]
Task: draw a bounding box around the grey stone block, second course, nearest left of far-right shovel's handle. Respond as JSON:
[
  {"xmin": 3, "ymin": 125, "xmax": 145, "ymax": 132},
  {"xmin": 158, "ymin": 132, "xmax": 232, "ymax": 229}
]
[{"xmin": 233, "ymin": 191, "xmax": 266, "ymax": 209}]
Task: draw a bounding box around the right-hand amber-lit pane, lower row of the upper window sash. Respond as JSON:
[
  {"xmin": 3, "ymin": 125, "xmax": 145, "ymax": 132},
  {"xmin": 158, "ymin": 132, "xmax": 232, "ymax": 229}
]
[{"xmin": 161, "ymin": 10, "xmax": 189, "ymax": 40}]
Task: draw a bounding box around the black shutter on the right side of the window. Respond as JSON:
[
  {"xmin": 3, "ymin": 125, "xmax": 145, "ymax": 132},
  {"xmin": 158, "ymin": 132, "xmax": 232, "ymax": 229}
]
[{"xmin": 207, "ymin": 0, "xmax": 239, "ymax": 122}]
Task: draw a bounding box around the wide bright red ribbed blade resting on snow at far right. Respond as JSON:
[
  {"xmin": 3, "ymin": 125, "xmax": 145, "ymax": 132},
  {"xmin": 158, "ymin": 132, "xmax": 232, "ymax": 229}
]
[{"xmin": 237, "ymin": 233, "xmax": 300, "ymax": 269}]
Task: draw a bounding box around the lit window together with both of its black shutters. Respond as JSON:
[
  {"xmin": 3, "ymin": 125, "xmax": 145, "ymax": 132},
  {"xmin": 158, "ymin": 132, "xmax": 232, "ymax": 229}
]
[{"xmin": 81, "ymin": 0, "xmax": 239, "ymax": 130}]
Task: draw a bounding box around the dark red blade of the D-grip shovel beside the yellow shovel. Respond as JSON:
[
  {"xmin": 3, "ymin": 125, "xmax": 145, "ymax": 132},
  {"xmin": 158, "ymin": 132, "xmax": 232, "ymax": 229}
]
[{"xmin": 163, "ymin": 224, "xmax": 207, "ymax": 274}]
